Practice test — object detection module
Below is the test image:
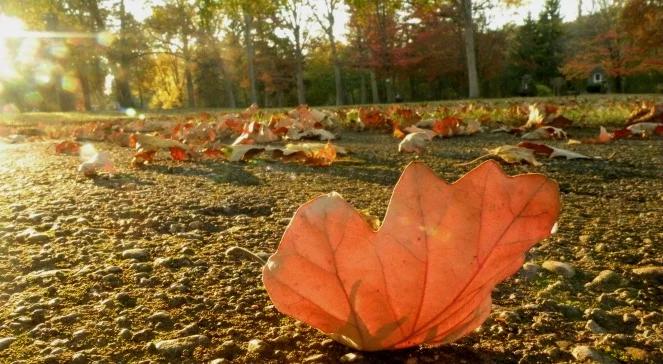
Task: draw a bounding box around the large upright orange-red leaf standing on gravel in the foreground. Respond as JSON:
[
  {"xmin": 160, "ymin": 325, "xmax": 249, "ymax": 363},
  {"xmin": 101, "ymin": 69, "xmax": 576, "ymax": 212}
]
[{"xmin": 263, "ymin": 161, "xmax": 560, "ymax": 351}]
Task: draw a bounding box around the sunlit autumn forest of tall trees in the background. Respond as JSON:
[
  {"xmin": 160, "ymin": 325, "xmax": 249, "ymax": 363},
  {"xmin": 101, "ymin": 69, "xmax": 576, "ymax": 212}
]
[{"xmin": 0, "ymin": 0, "xmax": 663, "ymax": 111}]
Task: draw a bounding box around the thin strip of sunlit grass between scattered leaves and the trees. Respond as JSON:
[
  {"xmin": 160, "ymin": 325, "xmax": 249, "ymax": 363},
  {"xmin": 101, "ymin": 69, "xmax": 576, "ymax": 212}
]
[{"xmin": 0, "ymin": 94, "xmax": 663, "ymax": 126}]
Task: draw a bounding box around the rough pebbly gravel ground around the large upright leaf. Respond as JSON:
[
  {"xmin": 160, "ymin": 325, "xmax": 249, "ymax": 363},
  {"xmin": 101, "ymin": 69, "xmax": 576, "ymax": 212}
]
[{"xmin": 0, "ymin": 129, "xmax": 663, "ymax": 364}]
